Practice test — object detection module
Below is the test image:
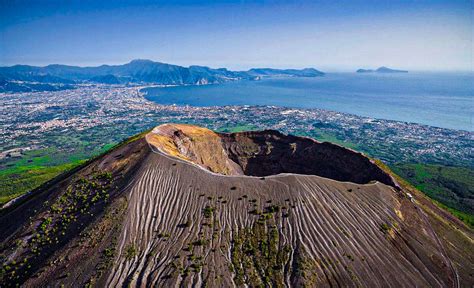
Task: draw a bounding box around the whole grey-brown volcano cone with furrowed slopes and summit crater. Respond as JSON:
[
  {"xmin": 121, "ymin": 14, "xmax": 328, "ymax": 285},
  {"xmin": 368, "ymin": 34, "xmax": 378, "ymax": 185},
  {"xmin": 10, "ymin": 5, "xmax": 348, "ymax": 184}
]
[{"xmin": 0, "ymin": 124, "xmax": 474, "ymax": 287}]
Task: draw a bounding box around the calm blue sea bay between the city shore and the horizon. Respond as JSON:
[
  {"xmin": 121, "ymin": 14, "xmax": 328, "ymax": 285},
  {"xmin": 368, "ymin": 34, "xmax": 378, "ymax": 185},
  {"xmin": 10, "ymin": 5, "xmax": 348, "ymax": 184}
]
[{"xmin": 144, "ymin": 73, "xmax": 474, "ymax": 131}]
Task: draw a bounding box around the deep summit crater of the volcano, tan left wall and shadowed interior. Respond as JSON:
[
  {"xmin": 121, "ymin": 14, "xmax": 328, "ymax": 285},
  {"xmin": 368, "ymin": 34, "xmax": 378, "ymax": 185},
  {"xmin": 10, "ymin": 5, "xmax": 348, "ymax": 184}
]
[{"xmin": 147, "ymin": 124, "xmax": 396, "ymax": 186}]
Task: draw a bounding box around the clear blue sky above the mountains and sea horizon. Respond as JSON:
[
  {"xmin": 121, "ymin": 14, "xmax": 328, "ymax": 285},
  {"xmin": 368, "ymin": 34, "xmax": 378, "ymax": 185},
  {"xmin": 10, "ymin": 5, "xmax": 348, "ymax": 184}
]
[{"xmin": 0, "ymin": 0, "xmax": 474, "ymax": 71}]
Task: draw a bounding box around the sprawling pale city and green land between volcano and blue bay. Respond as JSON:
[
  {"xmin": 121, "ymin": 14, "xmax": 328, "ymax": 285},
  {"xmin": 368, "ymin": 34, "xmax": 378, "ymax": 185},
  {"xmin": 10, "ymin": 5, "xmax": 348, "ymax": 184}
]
[{"xmin": 0, "ymin": 84, "xmax": 474, "ymax": 226}]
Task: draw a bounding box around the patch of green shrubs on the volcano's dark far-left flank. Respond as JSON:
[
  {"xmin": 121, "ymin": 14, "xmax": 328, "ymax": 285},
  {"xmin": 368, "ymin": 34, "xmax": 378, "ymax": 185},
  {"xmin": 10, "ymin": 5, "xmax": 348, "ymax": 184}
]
[{"xmin": 4, "ymin": 170, "xmax": 119, "ymax": 281}]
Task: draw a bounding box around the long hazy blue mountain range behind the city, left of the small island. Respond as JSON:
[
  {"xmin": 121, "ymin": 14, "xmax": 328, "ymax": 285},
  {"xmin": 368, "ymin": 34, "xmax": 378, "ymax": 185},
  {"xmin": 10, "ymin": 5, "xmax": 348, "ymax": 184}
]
[{"xmin": 0, "ymin": 60, "xmax": 324, "ymax": 92}]
